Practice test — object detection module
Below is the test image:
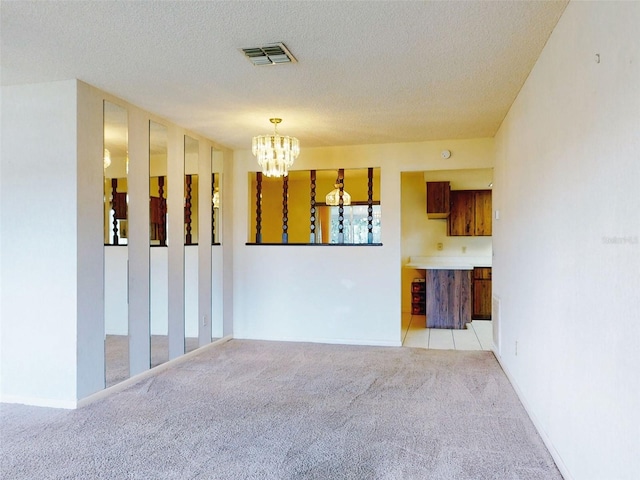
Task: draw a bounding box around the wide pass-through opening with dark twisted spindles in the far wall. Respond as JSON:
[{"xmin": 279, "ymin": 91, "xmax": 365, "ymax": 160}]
[{"xmin": 249, "ymin": 168, "xmax": 381, "ymax": 245}]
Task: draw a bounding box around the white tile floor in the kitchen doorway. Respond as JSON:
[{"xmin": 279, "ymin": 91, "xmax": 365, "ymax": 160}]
[{"xmin": 402, "ymin": 313, "xmax": 493, "ymax": 350}]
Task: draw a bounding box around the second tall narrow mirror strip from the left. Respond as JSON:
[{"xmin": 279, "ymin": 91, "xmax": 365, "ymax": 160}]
[{"xmin": 149, "ymin": 122, "xmax": 169, "ymax": 367}]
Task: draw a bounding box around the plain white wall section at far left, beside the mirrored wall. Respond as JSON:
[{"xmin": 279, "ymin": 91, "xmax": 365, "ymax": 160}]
[{"xmin": 0, "ymin": 81, "xmax": 84, "ymax": 406}]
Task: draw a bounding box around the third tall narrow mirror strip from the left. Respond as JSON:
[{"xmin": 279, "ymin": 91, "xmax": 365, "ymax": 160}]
[{"xmin": 184, "ymin": 135, "xmax": 200, "ymax": 353}]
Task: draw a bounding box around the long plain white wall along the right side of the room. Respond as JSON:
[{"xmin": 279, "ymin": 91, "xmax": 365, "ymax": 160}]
[{"xmin": 493, "ymin": 2, "xmax": 640, "ymax": 480}]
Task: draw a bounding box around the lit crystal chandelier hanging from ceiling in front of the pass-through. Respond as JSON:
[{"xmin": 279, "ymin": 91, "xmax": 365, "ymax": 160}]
[{"xmin": 251, "ymin": 118, "xmax": 300, "ymax": 177}]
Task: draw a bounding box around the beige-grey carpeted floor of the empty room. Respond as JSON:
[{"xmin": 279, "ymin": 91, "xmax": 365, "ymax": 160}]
[{"xmin": 0, "ymin": 340, "xmax": 562, "ymax": 480}]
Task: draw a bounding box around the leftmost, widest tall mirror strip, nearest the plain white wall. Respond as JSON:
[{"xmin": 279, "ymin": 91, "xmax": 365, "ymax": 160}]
[{"xmin": 102, "ymin": 101, "xmax": 129, "ymax": 387}]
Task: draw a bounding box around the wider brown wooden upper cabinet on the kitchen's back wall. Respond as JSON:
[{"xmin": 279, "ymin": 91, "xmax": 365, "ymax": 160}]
[{"xmin": 448, "ymin": 190, "xmax": 492, "ymax": 236}]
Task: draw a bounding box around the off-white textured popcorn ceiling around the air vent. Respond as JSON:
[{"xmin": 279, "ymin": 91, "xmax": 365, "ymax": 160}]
[{"xmin": 0, "ymin": 1, "xmax": 567, "ymax": 149}]
